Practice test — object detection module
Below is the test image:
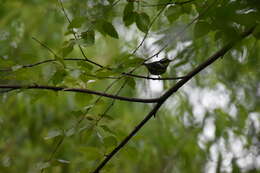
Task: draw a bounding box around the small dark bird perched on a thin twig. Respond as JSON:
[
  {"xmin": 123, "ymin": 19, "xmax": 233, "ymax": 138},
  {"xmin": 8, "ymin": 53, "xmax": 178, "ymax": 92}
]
[{"xmin": 144, "ymin": 58, "xmax": 172, "ymax": 75}]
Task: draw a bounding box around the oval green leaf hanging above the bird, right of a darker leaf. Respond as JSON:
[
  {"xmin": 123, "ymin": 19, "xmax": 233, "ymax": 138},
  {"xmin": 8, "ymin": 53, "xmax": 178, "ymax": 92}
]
[{"xmin": 135, "ymin": 12, "xmax": 150, "ymax": 33}]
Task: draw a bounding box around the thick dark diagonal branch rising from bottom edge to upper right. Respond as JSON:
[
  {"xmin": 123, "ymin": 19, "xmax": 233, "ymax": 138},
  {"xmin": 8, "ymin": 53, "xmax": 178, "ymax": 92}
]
[{"xmin": 93, "ymin": 26, "xmax": 255, "ymax": 173}]
